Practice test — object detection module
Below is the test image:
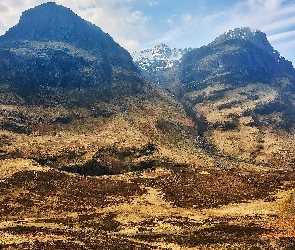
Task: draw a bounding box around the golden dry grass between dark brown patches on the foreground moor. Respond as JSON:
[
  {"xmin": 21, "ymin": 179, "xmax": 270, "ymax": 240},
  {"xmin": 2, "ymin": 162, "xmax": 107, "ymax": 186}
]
[{"xmin": 0, "ymin": 164, "xmax": 295, "ymax": 249}]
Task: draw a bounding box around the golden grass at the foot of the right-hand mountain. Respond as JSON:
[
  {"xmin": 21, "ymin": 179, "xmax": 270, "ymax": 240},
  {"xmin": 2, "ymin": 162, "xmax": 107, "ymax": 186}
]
[{"xmin": 210, "ymin": 125, "xmax": 295, "ymax": 164}]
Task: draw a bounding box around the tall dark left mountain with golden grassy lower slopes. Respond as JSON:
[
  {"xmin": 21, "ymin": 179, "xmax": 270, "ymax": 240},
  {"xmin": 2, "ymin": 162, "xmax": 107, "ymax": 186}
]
[{"xmin": 0, "ymin": 2, "xmax": 201, "ymax": 174}]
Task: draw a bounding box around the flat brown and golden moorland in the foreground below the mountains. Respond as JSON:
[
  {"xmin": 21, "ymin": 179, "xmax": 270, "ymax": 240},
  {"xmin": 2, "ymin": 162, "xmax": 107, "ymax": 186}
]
[{"xmin": 0, "ymin": 159, "xmax": 295, "ymax": 249}]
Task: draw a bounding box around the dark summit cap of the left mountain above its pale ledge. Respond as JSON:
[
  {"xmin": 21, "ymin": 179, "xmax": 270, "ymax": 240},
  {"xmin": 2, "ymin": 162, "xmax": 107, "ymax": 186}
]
[{"xmin": 0, "ymin": 2, "xmax": 138, "ymax": 70}]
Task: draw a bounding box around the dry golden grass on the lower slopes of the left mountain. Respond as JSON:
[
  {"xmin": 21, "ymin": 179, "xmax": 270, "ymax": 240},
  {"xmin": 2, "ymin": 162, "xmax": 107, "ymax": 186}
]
[{"xmin": 0, "ymin": 93, "xmax": 201, "ymax": 174}]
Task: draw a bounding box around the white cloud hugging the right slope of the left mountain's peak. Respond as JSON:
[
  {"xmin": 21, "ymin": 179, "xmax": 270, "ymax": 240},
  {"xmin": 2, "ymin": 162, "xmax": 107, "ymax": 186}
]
[{"xmin": 58, "ymin": 0, "xmax": 151, "ymax": 51}]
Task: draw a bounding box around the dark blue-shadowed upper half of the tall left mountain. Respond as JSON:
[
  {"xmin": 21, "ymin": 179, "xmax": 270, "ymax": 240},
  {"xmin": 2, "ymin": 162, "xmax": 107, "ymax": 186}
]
[{"xmin": 0, "ymin": 2, "xmax": 140, "ymax": 92}]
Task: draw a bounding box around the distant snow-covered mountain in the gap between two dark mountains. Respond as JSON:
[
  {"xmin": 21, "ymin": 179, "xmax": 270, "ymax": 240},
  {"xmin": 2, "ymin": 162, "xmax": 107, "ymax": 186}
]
[{"xmin": 131, "ymin": 43, "xmax": 192, "ymax": 86}]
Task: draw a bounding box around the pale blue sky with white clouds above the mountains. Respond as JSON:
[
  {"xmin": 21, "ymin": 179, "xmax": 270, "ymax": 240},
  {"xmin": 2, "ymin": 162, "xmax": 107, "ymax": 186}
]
[{"xmin": 0, "ymin": 0, "xmax": 295, "ymax": 66}]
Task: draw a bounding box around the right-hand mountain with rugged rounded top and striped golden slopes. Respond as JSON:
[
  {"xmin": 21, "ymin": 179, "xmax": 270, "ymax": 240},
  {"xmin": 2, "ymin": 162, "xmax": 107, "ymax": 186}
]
[{"xmin": 161, "ymin": 28, "xmax": 295, "ymax": 166}]
